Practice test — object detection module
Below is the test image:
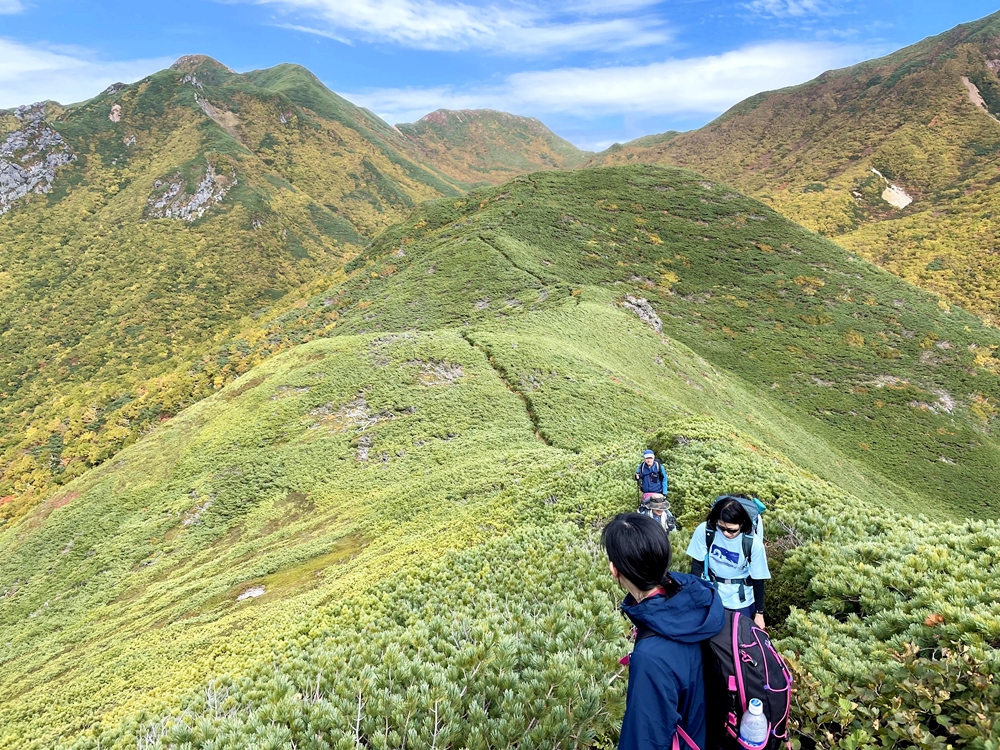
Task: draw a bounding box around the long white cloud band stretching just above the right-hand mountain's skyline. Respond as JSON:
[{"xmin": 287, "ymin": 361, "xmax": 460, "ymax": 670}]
[{"xmin": 344, "ymin": 42, "xmax": 883, "ymax": 122}]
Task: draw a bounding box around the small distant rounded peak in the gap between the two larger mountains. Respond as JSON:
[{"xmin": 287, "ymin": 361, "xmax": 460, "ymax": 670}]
[{"xmin": 396, "ymin": 109, "xmax": 592, "ymax": 185}]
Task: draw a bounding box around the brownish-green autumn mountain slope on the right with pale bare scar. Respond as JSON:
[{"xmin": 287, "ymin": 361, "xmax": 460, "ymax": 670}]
[{"xmin": 594, "ymin": 9, "xmax": 1000, "ymax": 323}]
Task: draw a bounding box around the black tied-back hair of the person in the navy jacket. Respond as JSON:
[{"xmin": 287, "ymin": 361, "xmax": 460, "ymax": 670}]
[{"xmin": 601, "ymin": 513, "xmax": 681, "ymax": 597}]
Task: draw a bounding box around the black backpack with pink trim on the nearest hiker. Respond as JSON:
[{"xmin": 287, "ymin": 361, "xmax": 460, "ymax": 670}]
[{"xmin": 702, "ymin": 611, "xmax": 792, "ymax": 750}]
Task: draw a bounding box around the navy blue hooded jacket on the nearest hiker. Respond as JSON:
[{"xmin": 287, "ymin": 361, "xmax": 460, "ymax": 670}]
[{"xmin": 618, "ymin": 573, "xmax": 725, "ymax": 750}]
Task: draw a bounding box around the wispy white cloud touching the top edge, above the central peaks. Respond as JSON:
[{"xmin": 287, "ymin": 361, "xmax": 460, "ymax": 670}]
[{"xmin": 250, "ymin": 0, "xmax": 670, "ymax": 54}]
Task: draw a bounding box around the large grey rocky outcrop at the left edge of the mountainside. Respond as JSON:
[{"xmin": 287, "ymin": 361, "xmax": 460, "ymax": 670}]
[{"xmin": 0, "ymin": 104, "xmax": 76, "ymax": 215}]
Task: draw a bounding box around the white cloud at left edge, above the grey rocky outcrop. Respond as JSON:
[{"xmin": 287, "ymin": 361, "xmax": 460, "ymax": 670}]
[{"xmin": 0, "ymin": 39, "xmax": 173, "ymax": 108}]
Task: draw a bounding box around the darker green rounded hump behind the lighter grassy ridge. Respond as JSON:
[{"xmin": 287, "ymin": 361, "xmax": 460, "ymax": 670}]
[{"xmin": 262, "ymin": 167, "xmax": 998, "ymax": 516}]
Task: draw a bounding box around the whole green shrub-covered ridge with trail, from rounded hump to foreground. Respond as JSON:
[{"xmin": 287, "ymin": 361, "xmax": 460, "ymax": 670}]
[{"xmin": 0, "ymin": 167, "xmax": 1000, "ymax": 750}]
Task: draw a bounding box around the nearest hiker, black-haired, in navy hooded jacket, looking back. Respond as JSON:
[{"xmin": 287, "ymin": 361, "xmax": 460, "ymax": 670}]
[{"xmin": 601, "ymin": 513, "xmax": 724, "ymax": 750}]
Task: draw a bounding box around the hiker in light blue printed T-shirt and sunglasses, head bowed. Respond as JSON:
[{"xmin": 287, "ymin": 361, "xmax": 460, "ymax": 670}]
[{"xmin": 687, "ymin": 495, "xmax": 771, "ymax": 629}]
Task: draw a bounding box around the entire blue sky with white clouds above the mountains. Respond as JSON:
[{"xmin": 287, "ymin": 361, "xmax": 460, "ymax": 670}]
[{"xmin": 0, "ymin": 0, "xmax": 998, "ymax": 149}]
